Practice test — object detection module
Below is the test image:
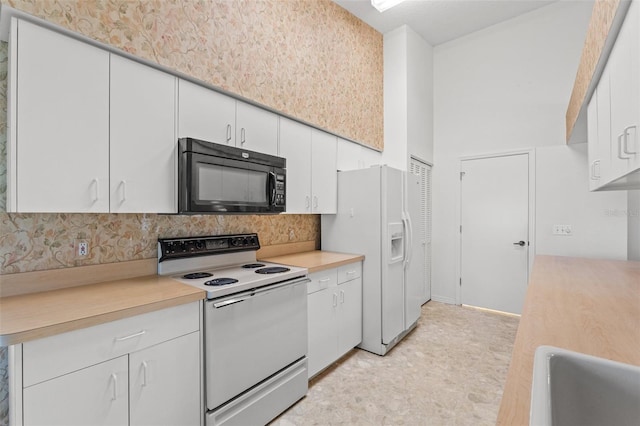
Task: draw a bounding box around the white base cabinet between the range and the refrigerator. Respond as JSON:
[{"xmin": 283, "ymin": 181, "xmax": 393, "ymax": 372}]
[{"xmin": 307, "ymin": 262, "xmax": 362, "ymax": 378}]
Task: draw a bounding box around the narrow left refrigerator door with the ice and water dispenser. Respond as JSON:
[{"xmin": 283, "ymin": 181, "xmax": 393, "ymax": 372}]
[{"xmin": 380, "ymin": 167, "xmax": 406, "ymax": 345}]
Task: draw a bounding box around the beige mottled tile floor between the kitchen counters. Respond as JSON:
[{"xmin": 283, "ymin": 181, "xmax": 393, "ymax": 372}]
[{"xmin": 272, "ymin": 302, "xmax": 518, "ymax": 426}]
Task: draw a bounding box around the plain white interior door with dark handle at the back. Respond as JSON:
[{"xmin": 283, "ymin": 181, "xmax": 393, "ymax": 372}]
[{"xmin": 461, "ymin": 153, "xmax": 529, "ymax": 314}]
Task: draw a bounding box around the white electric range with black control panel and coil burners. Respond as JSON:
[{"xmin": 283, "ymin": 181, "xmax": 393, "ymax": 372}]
[{"xmin": 158, "ymin": 234, "xmax": 309, "ymax": 426}]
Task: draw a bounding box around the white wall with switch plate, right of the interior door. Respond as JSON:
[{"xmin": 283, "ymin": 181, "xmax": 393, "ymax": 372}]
[{"xmin": 535, "ymin": 144, "xmax": 627, "ymax": 260}]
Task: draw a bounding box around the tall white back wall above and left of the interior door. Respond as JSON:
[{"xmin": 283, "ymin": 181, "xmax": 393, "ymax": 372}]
[{"xmin": 432, "ymin": 2, "xmax": 604, "ymax": 302}]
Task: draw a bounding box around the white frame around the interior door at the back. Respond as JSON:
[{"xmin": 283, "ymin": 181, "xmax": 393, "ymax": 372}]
[{"xmin": 455, "ymin": 148, "xmax": 536, "ymax": 305}]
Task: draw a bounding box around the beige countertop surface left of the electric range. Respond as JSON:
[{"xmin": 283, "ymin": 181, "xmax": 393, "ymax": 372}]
[{"xmin": 0, "ymin": 275, "xmax": 206, "ymax": 346}]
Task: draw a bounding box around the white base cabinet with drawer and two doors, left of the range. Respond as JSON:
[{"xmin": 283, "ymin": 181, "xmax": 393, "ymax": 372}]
[{"xmin": 12, "ymin": 302, "xmax": 203, "ymax": 426}]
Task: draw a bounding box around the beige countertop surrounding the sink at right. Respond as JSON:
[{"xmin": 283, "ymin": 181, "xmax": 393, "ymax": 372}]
[{"xmin": 497, "ymin": 256, "xmax": 640, "ymax": 425}]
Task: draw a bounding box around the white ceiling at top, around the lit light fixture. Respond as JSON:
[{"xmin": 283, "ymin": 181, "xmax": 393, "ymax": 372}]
[{"xmin": 333, "ymin": 0, "xmax": 556, "ymax": 46}]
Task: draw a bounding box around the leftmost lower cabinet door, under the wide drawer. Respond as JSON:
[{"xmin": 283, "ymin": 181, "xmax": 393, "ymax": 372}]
[{"xmin": 23, "ymin": 356, "xmax": 129, "ymax": 426}]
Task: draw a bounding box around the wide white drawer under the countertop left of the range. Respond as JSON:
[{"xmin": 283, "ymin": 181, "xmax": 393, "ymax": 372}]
[{"xmin": 23, "ymin": 302, "xmax": 200, "ymax": 387}]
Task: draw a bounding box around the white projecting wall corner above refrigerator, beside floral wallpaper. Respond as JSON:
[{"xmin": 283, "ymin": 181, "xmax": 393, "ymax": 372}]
[{"xmin": 382, "ymin": 25, "xmax": 433, "ymax": 170}]
